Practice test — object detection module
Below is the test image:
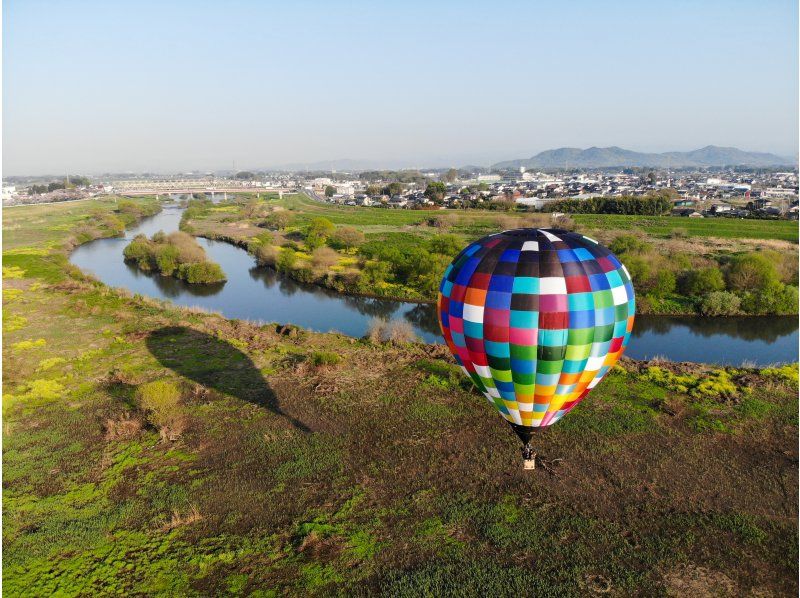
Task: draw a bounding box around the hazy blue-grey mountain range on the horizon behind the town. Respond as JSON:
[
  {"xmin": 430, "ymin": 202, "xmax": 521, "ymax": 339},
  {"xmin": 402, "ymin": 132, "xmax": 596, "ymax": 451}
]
[{"xmin": 492, "ymin": 145, "xmax": 796, "ymax": 170}]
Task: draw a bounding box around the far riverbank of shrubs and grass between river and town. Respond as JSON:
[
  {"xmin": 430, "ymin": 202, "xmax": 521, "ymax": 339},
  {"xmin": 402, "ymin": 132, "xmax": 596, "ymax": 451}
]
[{"xmin": 183, "ymin": 195, "xmax": 797, "ymax": 316}]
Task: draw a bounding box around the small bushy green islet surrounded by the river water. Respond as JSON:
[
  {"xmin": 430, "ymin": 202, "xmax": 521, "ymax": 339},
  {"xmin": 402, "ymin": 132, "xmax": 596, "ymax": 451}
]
[{"xmin": 124, "ymin": 231, "xmax": 225, "ymax": 284}]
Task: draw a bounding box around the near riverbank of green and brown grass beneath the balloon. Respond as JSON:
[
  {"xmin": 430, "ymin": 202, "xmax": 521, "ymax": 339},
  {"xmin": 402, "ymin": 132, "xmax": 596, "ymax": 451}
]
[{"xmin": 3, "ymin": 203, "xmax": 798, "ymax": 597}]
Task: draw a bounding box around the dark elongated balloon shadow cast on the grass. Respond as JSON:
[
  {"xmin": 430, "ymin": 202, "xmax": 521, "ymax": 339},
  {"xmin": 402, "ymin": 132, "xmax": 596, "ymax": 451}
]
[{"xmin": 145, "ymin": 326, "xmax": 310, "ymax": 432}]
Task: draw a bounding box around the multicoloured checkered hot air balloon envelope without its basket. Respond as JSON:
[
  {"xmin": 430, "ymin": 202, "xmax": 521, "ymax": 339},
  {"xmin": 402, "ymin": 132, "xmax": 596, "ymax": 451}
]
[{"xmin": 438, "ymin": 228, "xmax": 635, "ymax": 428}]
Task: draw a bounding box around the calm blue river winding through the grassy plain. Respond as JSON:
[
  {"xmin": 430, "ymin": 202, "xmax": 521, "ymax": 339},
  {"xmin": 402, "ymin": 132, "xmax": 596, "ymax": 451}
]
[{"xmin": 70, "ymin": 205, "xmax": 798, "ymax": 365}]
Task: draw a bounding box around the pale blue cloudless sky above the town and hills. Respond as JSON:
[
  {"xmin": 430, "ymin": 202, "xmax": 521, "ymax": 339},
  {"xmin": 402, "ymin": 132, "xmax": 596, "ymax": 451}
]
[{"xmin": 3, "ymin": 0, "xmax": 798, "ymax": 175}]
